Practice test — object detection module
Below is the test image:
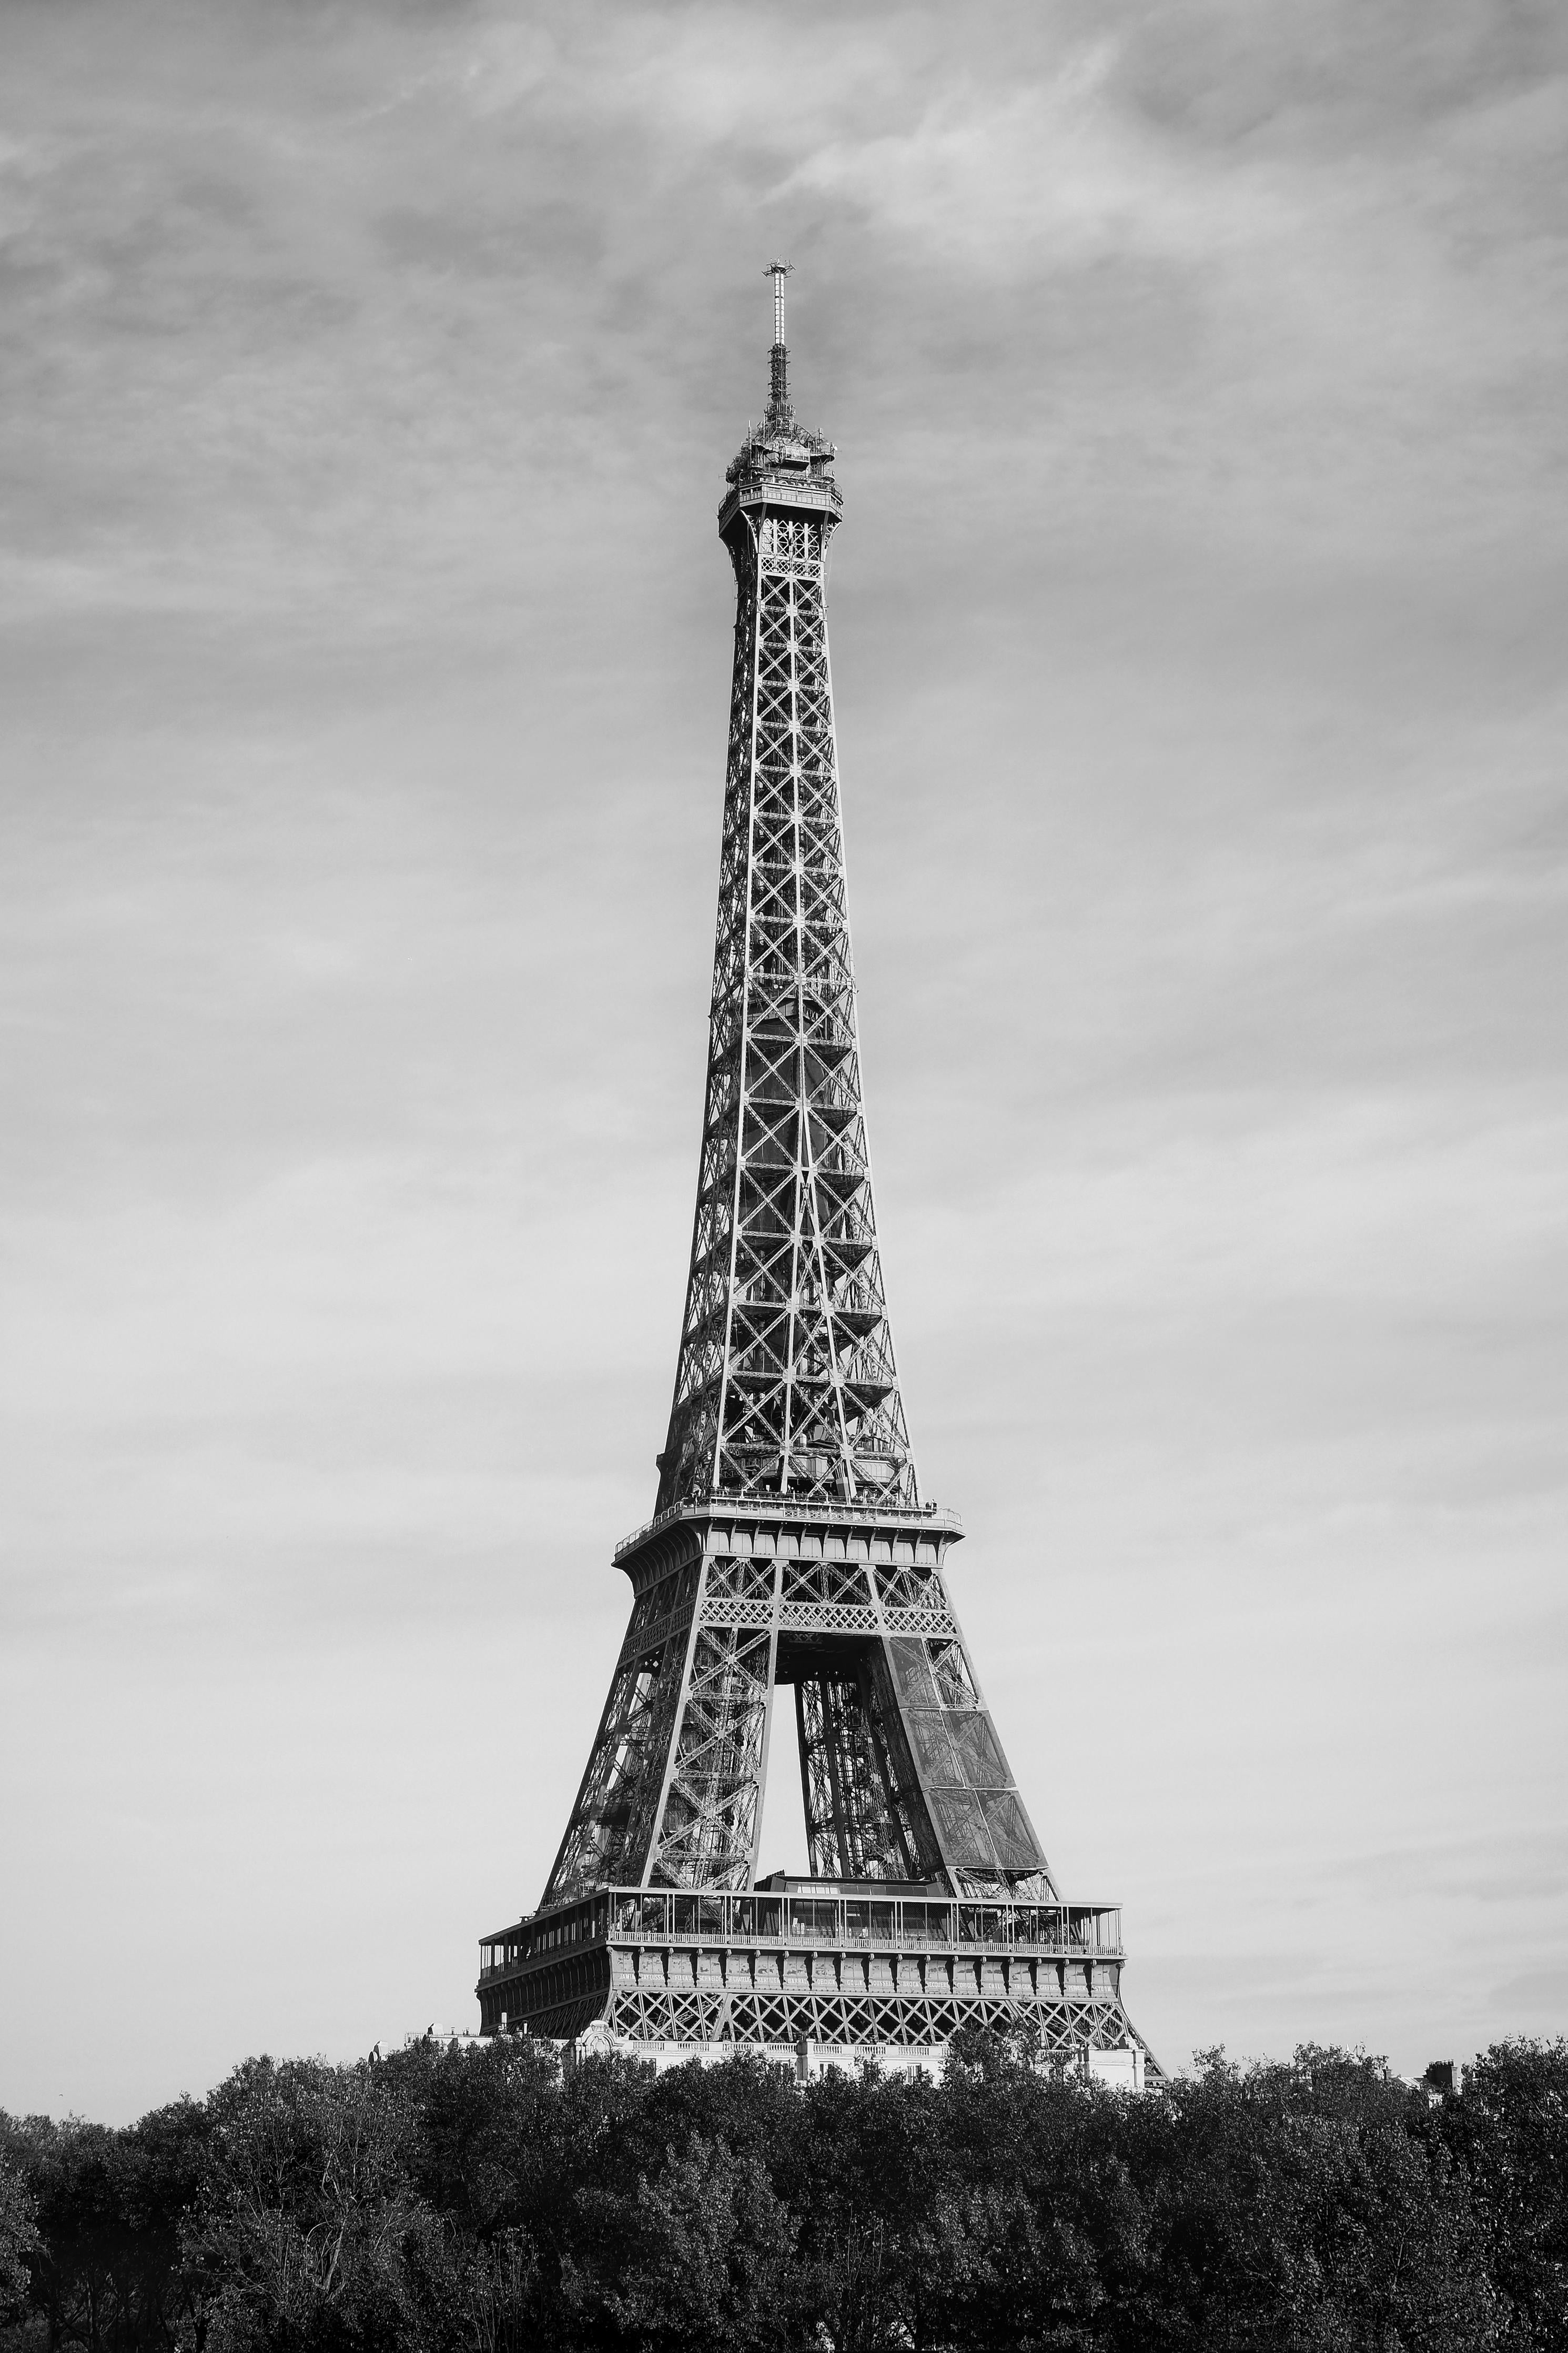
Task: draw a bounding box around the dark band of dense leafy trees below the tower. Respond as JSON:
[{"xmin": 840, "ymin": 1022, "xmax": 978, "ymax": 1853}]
[{"xmin": 0, "ymin": 2043, "xmax": 1568, "ymax": 2353}]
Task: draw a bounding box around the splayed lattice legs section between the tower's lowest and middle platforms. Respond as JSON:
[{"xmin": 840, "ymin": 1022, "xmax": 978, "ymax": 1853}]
[{"xmin": 543, "ymin": 1555, "xmax": 1056, "ymax": 1904}]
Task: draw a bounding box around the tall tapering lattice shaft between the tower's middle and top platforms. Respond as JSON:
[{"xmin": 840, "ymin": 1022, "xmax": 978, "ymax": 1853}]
[{"xmin": 658, "ymin": 510, "xmax": 917, "ymax": 1511}]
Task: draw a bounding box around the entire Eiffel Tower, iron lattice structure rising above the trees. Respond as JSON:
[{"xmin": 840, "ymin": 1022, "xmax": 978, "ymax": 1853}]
[{"xmin": 477, "ymin": 261, "xmax": 1159, "ymax": 2083}]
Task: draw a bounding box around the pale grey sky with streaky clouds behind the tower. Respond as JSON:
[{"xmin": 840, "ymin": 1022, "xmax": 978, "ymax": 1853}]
[{"xmin": 0, "ymin": 0, "xmax": 1568, "ymax": 2118}]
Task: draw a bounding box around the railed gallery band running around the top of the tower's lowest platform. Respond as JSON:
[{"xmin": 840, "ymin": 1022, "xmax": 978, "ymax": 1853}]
[{"xmin": 480, "ymin": 1887, "xmax": 1121, "ymax": 1981}]
